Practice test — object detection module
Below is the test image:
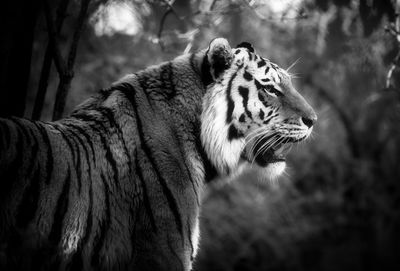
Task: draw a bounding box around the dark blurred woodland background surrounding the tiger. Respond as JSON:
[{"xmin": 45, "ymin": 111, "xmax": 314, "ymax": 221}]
[{"xmin": 0, "ymin": 0, "xmax": 400, "ymax": 271}]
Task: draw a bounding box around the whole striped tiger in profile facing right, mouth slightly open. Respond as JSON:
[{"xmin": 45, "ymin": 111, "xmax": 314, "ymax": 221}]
[{"xmin": 0, "ymin": 38, "xmax": 317, "ymax": 270}]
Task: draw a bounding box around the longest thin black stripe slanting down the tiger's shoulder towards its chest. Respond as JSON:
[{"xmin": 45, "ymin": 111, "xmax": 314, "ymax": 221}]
[{"xmin": 124, "ymin": 85, "xmax": 183, "ymax": 239}]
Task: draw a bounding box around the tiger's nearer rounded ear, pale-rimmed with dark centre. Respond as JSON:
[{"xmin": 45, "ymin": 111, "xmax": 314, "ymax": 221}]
[{"xmin": 207, "ymin": 38, "xmax": 233, "ymax": 81}]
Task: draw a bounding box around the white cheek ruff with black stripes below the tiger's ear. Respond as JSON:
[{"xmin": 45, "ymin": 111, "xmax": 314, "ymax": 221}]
[{"xmin": 201, "ymin": 65, "xmax": 273, "ymax": 175}]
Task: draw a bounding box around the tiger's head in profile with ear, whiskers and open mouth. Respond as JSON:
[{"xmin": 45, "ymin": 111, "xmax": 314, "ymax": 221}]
[{"xmin": 201, "ymin": 38, "xmax": 317, "ymax": 179}]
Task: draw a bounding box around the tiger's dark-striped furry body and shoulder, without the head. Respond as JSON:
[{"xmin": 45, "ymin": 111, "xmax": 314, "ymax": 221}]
[{"xmin": 0, "ymin": 52, "xmax": 205, "ymax": 270}]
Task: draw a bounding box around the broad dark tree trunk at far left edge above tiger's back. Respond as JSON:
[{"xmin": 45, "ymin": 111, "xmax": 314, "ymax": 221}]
[{"xmin": 0, "ymin": 0, "xmax": 40, "ymax": 117}]
